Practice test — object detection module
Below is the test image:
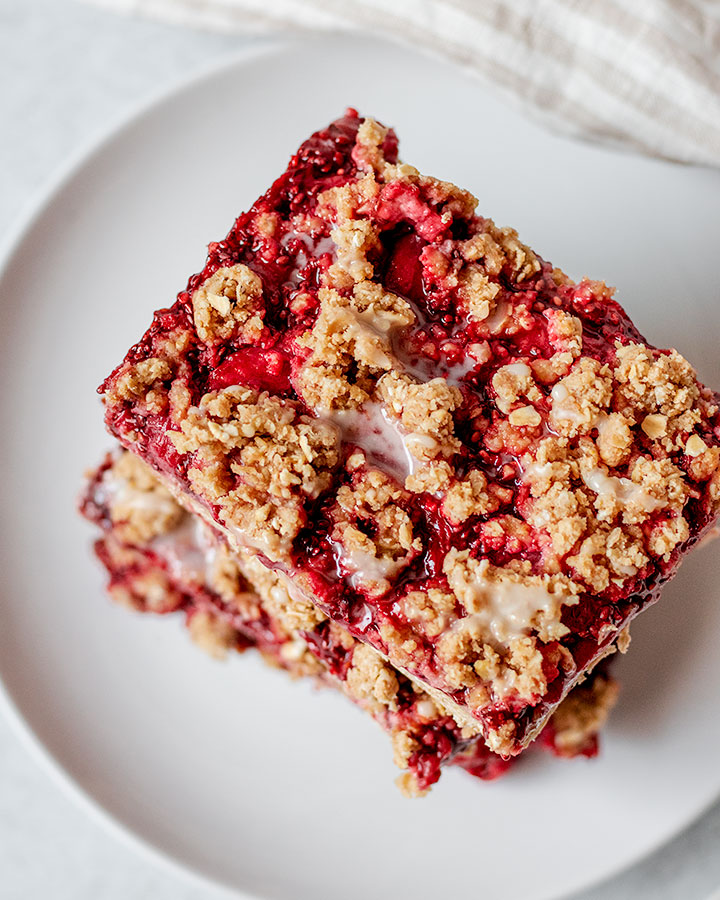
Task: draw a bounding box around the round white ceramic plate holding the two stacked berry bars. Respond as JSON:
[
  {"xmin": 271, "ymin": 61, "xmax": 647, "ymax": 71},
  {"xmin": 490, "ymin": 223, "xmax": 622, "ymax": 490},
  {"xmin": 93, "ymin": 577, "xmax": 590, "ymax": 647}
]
[{"xmin": 0, "ymin": 38, "xmax": 720, "ymax": 900}]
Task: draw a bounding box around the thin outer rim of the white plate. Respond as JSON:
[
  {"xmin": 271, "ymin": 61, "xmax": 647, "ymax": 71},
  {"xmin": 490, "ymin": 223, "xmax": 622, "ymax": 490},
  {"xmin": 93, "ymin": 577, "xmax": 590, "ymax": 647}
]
[{"xmin": 0, "ymin": 30, "xmax": 720, "ymax": 900}]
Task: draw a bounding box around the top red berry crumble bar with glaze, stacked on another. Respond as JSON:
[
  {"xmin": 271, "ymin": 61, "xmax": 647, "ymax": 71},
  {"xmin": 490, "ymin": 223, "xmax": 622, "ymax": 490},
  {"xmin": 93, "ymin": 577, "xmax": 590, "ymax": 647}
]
[{"xmin": 87, "ymin": 110, "xmax": 720, "ymax": 789}]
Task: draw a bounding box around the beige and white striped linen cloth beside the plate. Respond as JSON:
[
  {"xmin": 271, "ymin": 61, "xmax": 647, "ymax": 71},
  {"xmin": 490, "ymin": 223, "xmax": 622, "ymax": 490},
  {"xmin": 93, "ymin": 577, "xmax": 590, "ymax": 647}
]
[{"xmin": 81, "ymin": 0, "xmax": 720, "ymax": 166}]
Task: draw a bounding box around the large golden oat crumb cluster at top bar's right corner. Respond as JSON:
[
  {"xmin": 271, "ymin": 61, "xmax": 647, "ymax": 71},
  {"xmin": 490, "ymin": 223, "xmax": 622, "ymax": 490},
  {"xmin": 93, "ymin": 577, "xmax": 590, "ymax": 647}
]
[{"xmin": 523, "ymin": 334, "xmax": 720, "ymax": 591}]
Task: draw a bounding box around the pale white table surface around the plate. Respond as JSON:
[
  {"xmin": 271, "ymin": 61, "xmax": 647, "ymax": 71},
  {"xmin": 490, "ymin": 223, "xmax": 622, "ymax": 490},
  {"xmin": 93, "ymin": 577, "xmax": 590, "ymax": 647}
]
[{"xmin": 0, "ymin": 0, "xmax": 720, "ymax": 900}]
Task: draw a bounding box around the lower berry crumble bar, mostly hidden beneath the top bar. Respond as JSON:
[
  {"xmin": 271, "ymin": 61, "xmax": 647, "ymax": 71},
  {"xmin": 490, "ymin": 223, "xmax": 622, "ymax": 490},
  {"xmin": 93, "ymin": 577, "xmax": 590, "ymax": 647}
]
[{"xmin": 81, "ymin": 452, "xmax": 617, "ymax": 795}]
